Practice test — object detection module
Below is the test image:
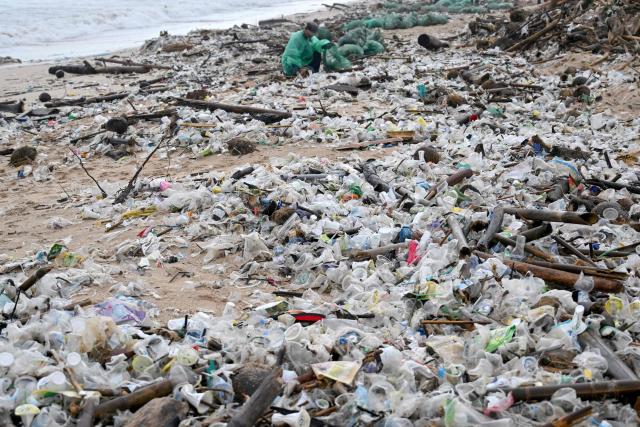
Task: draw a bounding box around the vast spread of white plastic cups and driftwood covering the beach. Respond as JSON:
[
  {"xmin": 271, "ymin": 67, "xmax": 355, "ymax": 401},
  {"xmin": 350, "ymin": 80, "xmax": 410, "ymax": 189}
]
[{"xmin": 0, "ymin": 0, "xmax": 640, "ymax": 427}]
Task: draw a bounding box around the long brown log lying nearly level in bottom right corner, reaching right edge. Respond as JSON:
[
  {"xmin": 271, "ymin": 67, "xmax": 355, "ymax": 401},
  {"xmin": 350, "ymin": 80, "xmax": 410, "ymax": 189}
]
[{"xmin": 502, "ymin": 380, "xmax": 640, "ymax": 402}]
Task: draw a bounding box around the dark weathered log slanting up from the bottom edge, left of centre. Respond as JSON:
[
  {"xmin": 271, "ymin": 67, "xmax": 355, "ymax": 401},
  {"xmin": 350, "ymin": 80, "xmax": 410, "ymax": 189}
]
[{"xmin": 227, "ymin": 367, "xmax": 284, "ymax": 427}]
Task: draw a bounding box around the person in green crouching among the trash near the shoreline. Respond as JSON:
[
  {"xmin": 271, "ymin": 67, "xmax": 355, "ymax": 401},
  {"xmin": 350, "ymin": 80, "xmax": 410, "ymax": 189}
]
[{"xmin": 281, "ymin": 22, "xmax": 331, "ymax": 76}]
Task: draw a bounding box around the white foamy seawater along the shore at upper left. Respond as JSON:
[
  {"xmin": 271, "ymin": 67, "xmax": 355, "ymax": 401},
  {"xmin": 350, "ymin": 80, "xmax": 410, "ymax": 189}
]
[{"xmin": 0, "ymin": 0, "xmax": 350, "ymax": 60}]
